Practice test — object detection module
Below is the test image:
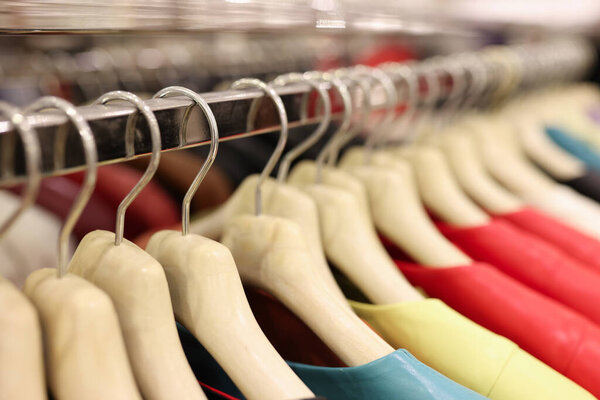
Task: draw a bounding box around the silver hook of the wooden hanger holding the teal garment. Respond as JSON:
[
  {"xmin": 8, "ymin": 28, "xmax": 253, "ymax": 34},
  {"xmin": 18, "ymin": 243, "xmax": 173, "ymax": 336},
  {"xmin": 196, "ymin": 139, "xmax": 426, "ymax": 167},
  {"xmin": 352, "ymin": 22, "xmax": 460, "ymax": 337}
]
[{"xmin": 231, "ymin": 78, "xmax": 288, "ymax": 215}]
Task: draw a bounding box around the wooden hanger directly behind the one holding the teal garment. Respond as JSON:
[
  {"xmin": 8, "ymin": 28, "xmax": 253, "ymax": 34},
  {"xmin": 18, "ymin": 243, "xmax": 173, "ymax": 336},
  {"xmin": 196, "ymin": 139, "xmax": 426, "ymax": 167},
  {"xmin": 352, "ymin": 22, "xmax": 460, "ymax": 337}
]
[{"xmin": 190, "ymin": 74, "xmax": 348, "ymax": 306}]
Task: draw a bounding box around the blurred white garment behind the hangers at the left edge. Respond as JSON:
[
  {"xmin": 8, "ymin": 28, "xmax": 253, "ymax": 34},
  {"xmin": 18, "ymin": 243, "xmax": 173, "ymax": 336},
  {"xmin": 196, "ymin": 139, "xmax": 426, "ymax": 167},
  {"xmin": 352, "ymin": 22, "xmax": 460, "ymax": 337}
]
[{"xmin": 0, "ymin": 191, "xmax": 75, "ymax": 288}]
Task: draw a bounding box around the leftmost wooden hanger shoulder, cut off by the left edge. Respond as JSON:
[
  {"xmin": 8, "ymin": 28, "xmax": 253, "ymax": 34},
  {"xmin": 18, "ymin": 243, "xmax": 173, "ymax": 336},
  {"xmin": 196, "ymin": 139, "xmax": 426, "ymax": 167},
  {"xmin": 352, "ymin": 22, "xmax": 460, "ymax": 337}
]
[{"xmin": 0, "ymin": 277, "xmax": 47, "ymax": 400}]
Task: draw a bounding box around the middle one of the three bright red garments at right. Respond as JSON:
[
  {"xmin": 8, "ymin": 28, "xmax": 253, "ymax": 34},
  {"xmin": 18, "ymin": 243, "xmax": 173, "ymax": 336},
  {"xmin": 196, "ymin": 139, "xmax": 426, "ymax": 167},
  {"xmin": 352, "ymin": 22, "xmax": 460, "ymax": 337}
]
[{"xmin": 436, "ymin": 219, "xmax": 600, "ymax": 324}]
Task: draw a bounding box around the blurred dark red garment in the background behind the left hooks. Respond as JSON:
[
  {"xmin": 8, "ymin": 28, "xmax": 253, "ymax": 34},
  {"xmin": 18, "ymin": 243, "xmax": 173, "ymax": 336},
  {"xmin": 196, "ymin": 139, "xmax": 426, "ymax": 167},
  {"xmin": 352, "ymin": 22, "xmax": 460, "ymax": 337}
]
[{"xmin": 66, "ymin": 165, "xmax": 180, "ymax": 238}]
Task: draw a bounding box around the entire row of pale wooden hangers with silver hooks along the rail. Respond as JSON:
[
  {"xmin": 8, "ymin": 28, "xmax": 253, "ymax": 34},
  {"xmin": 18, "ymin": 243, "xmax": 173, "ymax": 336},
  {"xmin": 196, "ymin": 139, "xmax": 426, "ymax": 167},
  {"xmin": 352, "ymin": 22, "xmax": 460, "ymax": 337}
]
[{"xmin": 0, "ymin": 36, "xmax": 590, "ymax": 400}]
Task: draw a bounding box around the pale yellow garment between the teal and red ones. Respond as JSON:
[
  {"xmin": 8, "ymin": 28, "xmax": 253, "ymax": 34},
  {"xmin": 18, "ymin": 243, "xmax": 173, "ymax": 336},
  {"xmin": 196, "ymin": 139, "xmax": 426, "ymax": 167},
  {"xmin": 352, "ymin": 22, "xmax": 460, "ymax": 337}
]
[{"xmin": 350, "ymin": 299, "xmax": 595, "ymax": 400}]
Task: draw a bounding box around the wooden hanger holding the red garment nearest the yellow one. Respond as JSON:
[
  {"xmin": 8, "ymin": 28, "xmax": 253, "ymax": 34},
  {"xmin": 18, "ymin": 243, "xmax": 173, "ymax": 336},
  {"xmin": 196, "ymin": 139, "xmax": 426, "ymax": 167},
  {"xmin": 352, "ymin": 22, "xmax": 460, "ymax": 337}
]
[{"xmin": 340, "ymin": 65, "xmax": 469, "ymax": 266}]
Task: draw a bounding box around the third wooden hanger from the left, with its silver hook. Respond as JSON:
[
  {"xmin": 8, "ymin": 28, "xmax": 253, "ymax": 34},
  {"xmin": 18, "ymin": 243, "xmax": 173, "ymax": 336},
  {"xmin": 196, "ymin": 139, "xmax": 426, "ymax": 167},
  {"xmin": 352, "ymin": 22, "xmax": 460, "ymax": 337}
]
[{"xmin": 69, "ymin": 91, "xmax": 206, "ymax": 400}]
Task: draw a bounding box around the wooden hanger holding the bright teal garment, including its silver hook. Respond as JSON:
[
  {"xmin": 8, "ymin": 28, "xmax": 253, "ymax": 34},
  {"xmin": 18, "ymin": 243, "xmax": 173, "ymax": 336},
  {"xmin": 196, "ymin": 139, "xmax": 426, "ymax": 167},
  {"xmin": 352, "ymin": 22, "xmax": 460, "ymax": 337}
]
[{"xmin": 222, "ymin": 76, "xmax": 394, "ymax": 365}]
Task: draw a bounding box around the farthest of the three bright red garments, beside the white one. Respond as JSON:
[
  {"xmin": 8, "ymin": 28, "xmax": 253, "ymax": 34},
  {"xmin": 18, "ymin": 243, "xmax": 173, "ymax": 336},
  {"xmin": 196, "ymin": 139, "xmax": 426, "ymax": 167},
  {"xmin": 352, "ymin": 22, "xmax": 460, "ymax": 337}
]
[{"xmin": 498, "ymin": 207, "xmax": 600, "ymax": 272}]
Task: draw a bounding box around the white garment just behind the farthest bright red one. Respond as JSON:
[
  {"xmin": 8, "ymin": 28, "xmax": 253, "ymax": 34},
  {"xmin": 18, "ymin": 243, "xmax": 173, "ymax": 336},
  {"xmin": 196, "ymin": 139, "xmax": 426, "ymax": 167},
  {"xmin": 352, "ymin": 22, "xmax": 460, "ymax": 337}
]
[{"xmin": 521, "ymin": 184, "xmax": 600, "ymax": 239}]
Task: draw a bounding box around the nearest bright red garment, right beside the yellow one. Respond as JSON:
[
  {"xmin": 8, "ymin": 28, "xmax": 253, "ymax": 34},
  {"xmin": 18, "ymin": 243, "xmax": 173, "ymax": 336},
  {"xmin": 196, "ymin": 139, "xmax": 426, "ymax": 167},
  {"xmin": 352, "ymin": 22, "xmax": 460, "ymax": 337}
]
[{"xmin": 396, "ymin": 260, "xmax": 600, "ymax": 397}]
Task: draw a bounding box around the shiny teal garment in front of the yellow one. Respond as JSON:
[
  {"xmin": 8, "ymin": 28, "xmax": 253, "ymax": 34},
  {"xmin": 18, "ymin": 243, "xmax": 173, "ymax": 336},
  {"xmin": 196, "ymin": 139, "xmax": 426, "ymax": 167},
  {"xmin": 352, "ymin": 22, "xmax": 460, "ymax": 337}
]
[{"xmin": 288, "ymin": 349, "xmax": 486, "ymax": 400}]
